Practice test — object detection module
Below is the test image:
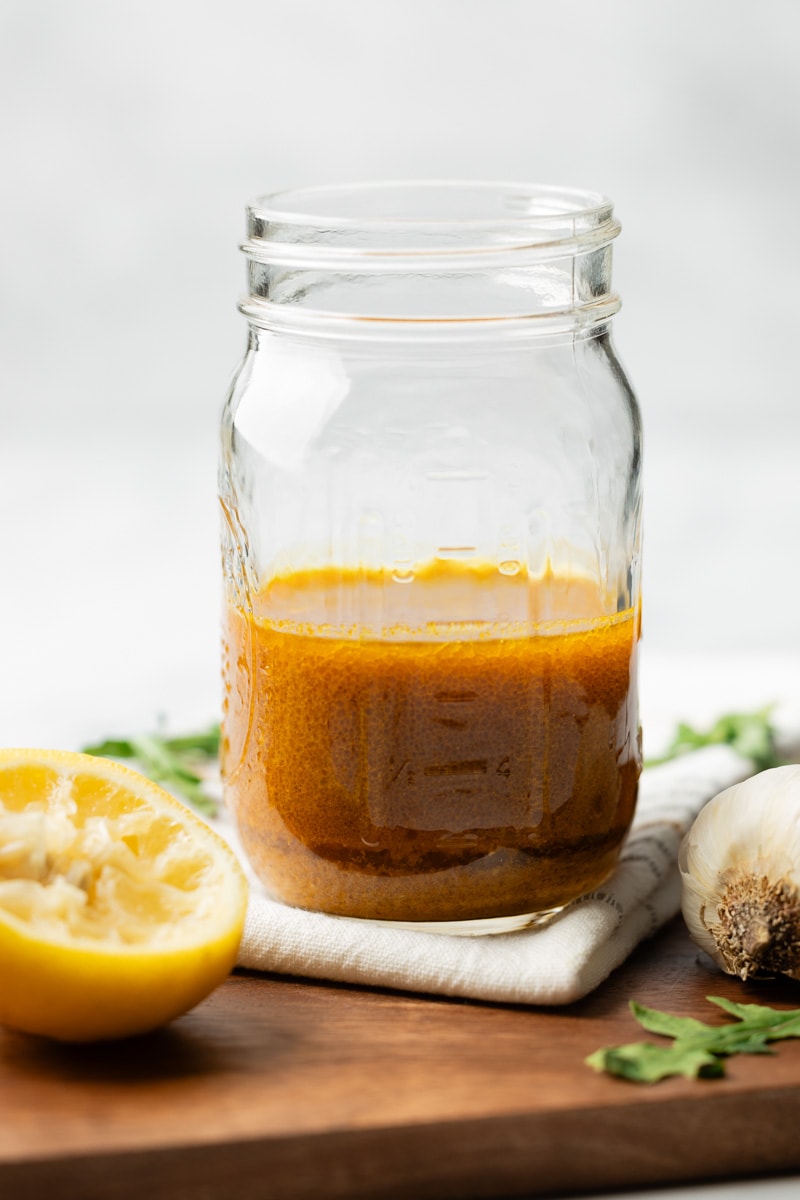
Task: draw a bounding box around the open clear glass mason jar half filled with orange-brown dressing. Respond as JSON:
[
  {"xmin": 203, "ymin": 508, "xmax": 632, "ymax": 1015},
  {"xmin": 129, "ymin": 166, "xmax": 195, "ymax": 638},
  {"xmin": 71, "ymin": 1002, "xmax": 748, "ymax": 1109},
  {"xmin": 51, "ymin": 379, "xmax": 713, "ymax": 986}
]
[{"xmin": 219, "ymin": 184, "xmax": 640, "ymax": 932}]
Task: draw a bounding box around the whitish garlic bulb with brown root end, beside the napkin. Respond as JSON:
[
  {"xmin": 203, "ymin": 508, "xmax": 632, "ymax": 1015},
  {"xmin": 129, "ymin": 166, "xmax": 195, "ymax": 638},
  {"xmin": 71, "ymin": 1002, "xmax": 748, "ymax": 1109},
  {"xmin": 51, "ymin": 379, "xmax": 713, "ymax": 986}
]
[{"xmin": 678, "ymin": 766, "xmax": 800, "ymax": 979}]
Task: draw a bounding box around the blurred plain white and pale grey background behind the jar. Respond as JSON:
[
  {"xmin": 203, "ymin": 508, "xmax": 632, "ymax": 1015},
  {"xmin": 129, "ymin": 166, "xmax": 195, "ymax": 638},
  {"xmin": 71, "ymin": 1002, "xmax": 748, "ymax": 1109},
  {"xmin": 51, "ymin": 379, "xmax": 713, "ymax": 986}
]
[{"xmin": 0, "ymin": 0, "xmax": 800, "ymax": 746}]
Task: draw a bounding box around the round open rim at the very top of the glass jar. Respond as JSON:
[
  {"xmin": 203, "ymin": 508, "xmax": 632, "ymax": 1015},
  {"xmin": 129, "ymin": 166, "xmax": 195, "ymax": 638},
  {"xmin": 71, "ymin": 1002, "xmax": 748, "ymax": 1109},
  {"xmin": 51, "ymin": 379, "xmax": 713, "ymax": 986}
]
[{"xmin": 242, "ymin": 180, "xmax": 620, "ymax": 262}]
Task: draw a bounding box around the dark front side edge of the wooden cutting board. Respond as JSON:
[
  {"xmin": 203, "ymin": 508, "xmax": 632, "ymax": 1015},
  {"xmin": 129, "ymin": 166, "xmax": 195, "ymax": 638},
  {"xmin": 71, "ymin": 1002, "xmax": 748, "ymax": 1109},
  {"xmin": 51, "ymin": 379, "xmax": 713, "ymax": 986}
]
[{"xmin": 0, "ymin": 1084, "xmax": 800, "ymax": 1200}]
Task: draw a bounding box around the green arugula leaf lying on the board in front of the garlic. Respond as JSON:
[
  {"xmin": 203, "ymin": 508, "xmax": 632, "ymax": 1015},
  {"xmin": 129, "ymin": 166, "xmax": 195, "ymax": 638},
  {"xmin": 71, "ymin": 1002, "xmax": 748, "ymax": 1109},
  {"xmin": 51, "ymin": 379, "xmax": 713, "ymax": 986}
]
[{"xmin": 585, "ymin": 996, "xmax": 800, "ymax": 1084}]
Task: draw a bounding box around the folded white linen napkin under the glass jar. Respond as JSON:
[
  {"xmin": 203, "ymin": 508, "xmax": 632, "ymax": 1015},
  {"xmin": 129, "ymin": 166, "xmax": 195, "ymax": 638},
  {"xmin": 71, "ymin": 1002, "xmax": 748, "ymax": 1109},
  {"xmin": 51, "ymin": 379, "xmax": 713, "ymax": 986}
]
[{"xmin": 225, "ymin": 746, "xmax": 752, "ymax": 1004}]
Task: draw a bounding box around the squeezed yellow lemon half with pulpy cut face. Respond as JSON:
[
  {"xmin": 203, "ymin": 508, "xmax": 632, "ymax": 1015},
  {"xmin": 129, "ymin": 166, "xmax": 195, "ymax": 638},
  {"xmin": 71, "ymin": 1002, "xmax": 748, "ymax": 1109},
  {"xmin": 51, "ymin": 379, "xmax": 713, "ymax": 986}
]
[{"xmin": 0, "ymin": 750, "xmax": 247, "ymax": 1042}]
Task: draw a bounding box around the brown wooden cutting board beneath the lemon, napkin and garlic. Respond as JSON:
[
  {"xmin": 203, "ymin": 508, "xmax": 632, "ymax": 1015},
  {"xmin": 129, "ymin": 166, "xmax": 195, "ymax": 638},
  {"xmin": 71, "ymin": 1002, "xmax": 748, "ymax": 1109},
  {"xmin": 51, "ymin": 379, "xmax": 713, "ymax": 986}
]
[{"xmin": 0, "ymin": 922, "xmax": 800, "ymax": 1200}]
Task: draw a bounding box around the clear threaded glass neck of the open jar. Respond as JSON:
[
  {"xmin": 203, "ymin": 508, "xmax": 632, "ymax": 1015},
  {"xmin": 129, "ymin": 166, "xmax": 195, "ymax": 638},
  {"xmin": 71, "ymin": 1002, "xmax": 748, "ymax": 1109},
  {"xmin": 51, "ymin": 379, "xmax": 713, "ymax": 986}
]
[{"xmin": 241, "ymin": 184, "xmax": 620, "ymax": 336}]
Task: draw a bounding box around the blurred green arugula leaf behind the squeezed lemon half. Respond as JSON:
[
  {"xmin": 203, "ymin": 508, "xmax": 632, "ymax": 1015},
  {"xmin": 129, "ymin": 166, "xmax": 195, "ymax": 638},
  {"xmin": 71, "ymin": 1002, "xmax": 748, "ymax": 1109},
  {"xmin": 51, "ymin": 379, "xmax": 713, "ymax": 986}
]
[{"xmin": 82, "ymin": 725, "xmax": 219, "ymax": 816}]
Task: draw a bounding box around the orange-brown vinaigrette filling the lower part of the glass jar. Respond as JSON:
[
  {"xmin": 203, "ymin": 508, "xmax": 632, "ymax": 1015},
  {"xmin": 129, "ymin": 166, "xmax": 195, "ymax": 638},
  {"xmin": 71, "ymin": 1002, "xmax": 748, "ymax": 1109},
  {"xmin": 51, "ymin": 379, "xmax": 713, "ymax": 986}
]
[{"xmin": 223, "ymin": 564, "xmax": 640, "ymax": 922}]
